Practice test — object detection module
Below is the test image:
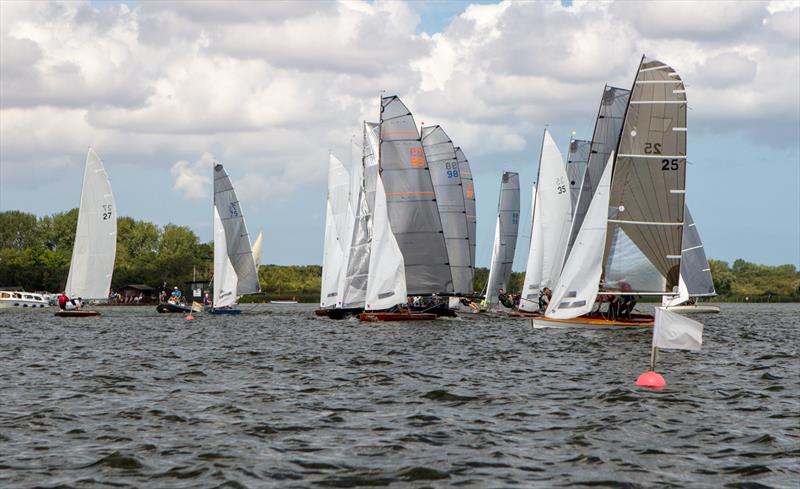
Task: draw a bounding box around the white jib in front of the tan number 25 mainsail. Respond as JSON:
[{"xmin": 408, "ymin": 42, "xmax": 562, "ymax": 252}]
[{"xmin": 545, "ymin": 152, "xmax": 614, "ymax": 319}]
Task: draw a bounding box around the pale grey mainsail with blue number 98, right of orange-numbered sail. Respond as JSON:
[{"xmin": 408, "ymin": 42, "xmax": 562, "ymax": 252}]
[{"xmin": 422, "ymin": 126, "xmax": 473, "ymax": 295}]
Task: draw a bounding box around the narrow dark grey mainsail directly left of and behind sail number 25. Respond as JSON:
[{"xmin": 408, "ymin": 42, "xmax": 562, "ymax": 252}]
[{"xmin": 567, "ymin": 85, "xmax": 631, "ymax": 260}]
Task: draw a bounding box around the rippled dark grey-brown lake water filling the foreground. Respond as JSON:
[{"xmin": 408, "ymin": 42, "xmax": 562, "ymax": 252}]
[{"xmin": 0, "ymin": 304, "xmax": 800, "ymax": 488}]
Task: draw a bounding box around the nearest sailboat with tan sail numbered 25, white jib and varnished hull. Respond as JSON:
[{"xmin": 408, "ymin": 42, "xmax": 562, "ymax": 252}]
[{"xmin": 533, "ymin": 57, "xmax": 687, "ymax": 327}]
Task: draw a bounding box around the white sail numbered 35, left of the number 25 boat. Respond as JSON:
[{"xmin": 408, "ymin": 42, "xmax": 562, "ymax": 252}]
[{"xmin": 519, "ymin": 129, "xmax": 573, "ymax": 315}]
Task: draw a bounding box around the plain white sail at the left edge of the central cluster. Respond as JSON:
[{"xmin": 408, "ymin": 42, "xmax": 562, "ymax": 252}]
[{"xmin": 320, "ymin": 154, "xmax": 352, "ymax": 307}]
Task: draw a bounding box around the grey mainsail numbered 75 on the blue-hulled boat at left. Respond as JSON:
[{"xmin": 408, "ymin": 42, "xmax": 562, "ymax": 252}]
[{"xmin": 214, "ymin": 164, "xmax": 261, "ymax": 307}]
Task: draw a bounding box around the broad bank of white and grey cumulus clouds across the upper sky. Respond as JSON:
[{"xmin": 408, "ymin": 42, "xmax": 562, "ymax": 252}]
[{"xmin": 0, "ymin": 0, "xmax": 800, "ymax": 200}]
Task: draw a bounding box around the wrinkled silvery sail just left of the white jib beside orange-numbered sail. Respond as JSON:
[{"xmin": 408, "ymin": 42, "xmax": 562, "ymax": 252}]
[{"xmin": 338, "ymin": 122, "xmax": 378, "ymax": 308}]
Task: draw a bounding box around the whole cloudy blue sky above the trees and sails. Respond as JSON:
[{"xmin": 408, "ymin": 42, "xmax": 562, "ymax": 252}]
[{"xmin": 0, "ymin": 0, "xmax": 800, "ymax": 270}]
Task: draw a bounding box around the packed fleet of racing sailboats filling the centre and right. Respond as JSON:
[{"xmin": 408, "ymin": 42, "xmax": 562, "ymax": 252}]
[{"xmin": 317, "ymin": 57, "xmax": 718, "ymax": 328}]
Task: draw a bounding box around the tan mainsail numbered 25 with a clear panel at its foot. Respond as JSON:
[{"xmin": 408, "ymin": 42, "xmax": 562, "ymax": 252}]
[{"xmin": 603, "ymin": 57, "xmax": 687, "ymax": 294}]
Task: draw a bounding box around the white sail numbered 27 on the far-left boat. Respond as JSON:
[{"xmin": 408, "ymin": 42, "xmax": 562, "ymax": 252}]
[{"xmin": 64, "ymin": 148, "xmax": 117, "ymax": 299}]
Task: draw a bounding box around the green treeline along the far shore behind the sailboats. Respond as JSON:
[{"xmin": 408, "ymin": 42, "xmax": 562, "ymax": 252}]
[{"xmin": 0, "ymin": 209, "xmax": 800, "ymax": 302}]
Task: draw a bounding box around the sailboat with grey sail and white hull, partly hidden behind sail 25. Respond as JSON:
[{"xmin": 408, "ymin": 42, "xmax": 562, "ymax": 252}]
[{"xmin": 664, "ymin": 206, "xmax": 720, "ymax": 314}]
